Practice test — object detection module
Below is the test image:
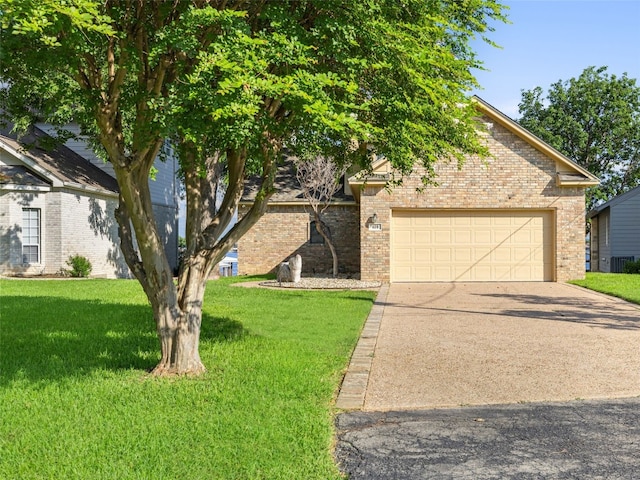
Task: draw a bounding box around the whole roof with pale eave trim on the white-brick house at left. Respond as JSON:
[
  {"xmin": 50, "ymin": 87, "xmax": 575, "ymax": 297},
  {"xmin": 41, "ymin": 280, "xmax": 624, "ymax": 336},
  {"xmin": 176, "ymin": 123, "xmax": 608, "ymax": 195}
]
[{"xmin": 0, "ymin": 127, "xmax": 118, "ymax": 195}]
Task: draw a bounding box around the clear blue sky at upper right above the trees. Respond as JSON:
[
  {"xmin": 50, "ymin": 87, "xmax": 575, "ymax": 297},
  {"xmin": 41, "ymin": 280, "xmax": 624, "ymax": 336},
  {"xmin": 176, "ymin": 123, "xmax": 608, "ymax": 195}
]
[{"xmin": 473, "ymin": 0, "xmax": 640, "ymax": 118}]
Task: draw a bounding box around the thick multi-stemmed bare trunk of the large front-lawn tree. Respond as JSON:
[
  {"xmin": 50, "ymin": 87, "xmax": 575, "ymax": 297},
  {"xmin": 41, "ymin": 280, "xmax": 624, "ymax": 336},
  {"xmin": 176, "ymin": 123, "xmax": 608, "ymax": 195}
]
[{"xmin": 114, "ymin": 141, "xmax": 276, "ymax": 375}]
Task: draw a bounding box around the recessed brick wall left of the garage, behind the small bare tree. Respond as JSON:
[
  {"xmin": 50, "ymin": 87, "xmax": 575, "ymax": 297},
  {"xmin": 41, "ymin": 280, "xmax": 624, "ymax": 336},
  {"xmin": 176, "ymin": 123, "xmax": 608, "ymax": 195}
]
[{"xmin": 238, "ymin": 204, "xmax": 360, "ymax": 275}]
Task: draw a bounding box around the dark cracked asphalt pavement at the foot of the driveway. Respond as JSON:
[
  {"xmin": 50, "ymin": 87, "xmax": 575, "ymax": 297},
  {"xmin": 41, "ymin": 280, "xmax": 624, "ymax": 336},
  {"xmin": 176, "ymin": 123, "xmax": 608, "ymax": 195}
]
[{"xmin": 336, "ymin": 398, "xmax": 640, "ymax": 480}]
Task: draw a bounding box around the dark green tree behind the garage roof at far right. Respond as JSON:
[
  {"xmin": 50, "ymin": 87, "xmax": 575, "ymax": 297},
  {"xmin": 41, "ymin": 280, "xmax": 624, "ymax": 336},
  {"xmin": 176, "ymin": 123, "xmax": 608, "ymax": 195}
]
[{"xmin": 518, "ymin": 67, "xmax": 640, "ymax": 209}]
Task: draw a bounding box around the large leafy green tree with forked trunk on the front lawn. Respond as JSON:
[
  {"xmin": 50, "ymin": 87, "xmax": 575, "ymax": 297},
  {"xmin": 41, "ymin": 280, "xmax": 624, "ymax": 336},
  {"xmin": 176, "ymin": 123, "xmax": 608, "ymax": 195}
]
[{"xmin": 0, "ymin": 0, "xmax": 503, "ymax": 374}]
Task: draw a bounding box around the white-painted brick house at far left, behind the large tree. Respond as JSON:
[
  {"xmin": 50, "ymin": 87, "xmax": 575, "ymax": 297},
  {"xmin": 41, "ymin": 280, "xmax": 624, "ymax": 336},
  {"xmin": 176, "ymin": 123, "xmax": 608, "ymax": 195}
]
[{"xmin": 0, "ymin": 127, "xmax": 178, "ymax": 278}]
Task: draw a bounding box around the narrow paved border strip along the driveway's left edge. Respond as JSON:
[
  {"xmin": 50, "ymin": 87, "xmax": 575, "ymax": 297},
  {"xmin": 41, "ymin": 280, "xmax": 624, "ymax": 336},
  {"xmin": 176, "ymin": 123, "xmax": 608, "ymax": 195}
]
[{"xmin": 336, "ymin": 283, "xmax": 389, "ymax": 410}]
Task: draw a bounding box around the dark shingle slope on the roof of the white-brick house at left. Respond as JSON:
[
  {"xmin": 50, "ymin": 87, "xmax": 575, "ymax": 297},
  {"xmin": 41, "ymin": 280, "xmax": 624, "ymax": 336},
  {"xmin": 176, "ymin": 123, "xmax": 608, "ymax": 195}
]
[{"xmin": 0, "ymin": 127, "xmax": 118, "ymax": 193}]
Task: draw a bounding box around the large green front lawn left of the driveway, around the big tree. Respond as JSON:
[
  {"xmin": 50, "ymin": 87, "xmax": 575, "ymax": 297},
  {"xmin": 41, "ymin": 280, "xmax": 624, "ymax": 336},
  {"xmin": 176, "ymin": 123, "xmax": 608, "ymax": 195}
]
[{"xmin": 0, "ymin": 279, "xmax": 375, "ymax": 480}]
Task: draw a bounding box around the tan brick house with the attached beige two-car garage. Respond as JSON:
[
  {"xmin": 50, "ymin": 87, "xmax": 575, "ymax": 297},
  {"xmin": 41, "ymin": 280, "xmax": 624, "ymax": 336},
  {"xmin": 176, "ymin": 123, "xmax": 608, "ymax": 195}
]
[{"xmin": 238, "ymin": 97, "xmax": 599, "ymax": 282}]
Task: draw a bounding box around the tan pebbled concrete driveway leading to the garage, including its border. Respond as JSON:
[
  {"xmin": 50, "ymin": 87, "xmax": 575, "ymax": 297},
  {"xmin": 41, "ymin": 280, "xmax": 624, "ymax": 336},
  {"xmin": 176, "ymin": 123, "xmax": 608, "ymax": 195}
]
[{"xmin": 337, "ymin": 283, "xmax": 640, "ymax": 411}]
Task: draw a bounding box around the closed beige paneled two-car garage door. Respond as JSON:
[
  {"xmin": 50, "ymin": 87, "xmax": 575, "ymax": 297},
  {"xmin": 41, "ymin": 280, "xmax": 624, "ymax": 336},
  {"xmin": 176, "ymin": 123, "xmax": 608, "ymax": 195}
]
[{"xmin": 391, "ymin": 210, "xmax": 554, "ymax": 282}]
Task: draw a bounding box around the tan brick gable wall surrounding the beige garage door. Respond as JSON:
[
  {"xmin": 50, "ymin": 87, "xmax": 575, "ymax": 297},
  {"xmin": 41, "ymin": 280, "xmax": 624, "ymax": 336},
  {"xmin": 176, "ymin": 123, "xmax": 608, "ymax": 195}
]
[{"xmin": 360, "ymin": 119, "xmax": 585, "ymax": 281}]
